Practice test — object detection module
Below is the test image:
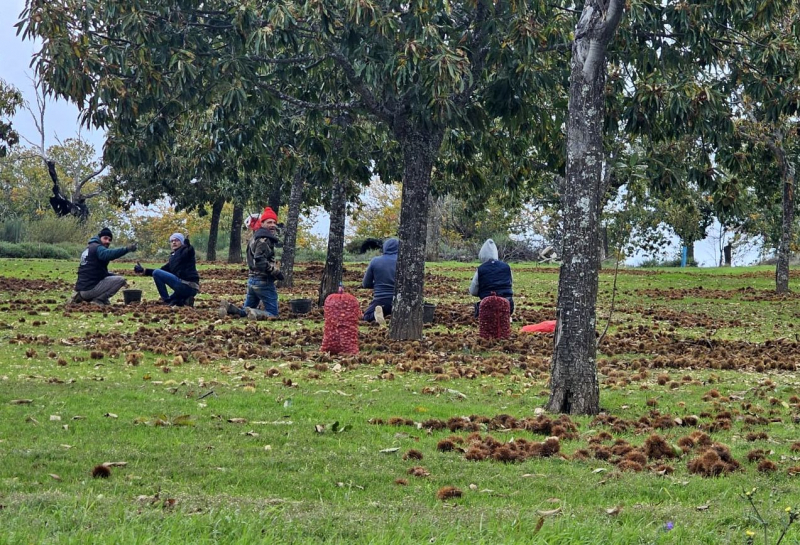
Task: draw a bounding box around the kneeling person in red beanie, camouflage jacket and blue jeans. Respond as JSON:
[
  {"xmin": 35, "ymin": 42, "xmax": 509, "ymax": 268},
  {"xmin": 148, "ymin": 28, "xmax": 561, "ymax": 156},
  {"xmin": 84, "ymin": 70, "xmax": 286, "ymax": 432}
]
[{"xmin": 219, "ymin": 206, "xmax": 284, "ymax": 320}]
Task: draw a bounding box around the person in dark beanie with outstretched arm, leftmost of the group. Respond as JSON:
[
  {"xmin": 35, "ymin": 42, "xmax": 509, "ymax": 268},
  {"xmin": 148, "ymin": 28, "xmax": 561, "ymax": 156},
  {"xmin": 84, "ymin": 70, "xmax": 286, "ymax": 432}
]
[{"xmin": 67, "ymin": 227, "xmax": 136, "ymax": 306}]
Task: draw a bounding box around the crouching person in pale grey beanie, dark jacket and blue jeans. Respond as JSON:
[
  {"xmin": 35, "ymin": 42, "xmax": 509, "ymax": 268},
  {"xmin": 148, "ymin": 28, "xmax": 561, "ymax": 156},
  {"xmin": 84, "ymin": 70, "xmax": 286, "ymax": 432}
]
[{"xmin": 133, "ymin": 233, "xmax": 200, "ymax": 307}]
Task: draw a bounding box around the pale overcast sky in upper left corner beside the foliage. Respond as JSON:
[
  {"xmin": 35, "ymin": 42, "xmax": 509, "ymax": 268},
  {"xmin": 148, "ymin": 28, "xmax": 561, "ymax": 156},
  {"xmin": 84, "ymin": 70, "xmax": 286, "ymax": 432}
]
[{"xmin": 0, "ymin": 0, "xmax": 104, "ymax": 155}]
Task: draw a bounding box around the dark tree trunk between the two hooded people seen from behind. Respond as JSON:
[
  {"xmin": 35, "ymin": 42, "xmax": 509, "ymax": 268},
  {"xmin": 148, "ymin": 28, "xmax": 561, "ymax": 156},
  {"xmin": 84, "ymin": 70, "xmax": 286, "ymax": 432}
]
[{"xmin": 389, "ymin": 126, "xmax": 443, "ymax": 340}]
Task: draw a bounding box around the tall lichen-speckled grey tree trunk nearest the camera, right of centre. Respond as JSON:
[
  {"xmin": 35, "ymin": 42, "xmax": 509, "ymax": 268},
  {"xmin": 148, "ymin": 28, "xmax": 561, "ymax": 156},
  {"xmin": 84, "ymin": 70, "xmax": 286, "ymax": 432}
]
[{"xmin": 547, "ymin": 0, "xmax": 622, "ymax": 414}]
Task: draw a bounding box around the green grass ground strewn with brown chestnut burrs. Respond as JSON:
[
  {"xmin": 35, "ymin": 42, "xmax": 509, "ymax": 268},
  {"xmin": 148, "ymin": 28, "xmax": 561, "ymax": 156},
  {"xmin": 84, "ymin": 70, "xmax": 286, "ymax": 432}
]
[{"xmin": 0, "ymin": 260, "xmax": 800, "ymax": 544}]
